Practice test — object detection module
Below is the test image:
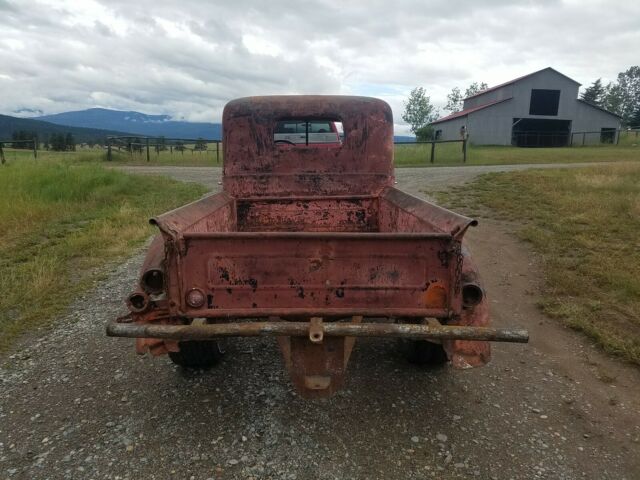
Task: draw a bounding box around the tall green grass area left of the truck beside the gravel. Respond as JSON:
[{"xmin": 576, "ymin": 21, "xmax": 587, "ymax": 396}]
[{"xmin": 0, "ymin": 159, "xmax": 204, "ymax": 351}]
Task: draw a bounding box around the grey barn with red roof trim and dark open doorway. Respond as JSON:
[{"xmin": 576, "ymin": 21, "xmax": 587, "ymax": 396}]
[{"xmin": 431, "ymin": 67, "xmax": 621, "ymax": 147}]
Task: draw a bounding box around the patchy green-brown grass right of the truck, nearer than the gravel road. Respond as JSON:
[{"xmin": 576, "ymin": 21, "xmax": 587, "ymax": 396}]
[{"xmin": 447, "ymin": 164, "xmax": 640, "ymax": 365}]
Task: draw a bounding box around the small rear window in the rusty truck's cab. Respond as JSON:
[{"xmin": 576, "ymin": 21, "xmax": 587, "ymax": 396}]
[{"xmin": 273, "ymin": 118, "xmax": 344, "ymax": 147}]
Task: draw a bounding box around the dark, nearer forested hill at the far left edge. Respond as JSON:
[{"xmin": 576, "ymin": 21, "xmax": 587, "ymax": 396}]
[{"xmin": 0, "ymin": 115, "xmax": 125, "ymax": 143}]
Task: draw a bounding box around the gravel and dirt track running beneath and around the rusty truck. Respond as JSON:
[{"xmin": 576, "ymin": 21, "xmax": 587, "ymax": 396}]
[{"xmin": 0, "ymin": 163, "xmax": 640, "ymax": 480}]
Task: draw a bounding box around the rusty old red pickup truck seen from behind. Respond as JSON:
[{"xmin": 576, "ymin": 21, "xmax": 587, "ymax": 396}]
[{"xmin": 107, "ymin": 96, "xmax": 528, "ymax": 397}]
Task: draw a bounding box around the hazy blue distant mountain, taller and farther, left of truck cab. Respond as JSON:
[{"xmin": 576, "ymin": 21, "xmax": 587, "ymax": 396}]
[{"xmin": 37, "ymin": 108, "xmax": 222, "ymax": 140}]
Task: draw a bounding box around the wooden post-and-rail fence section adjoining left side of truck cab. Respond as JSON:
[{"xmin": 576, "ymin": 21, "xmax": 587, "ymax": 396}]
[{"xmin": 106, "ymin": 135, "xmax": 222, "ymax": 163}]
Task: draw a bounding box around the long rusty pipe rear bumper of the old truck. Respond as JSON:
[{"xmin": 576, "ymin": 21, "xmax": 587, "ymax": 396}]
[{"xmin": 107, "ymin": 320, "xmax": 529, "ymax": 343}]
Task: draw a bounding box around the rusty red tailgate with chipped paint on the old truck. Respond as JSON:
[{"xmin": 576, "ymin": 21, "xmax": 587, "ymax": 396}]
[{"xmin": 174, "ymin": 232, "xmax": 460, "ymax": 318}]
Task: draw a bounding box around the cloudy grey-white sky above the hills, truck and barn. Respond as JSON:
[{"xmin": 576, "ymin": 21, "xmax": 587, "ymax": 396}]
[{"xmin": 0, "ymin": 0, "xmax": 640, "ymax": 134}]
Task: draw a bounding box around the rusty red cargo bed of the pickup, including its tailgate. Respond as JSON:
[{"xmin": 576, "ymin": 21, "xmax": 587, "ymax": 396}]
[{"xmin": 152, "ymin": 188, "xmax": 475, "ymax": 318}]
